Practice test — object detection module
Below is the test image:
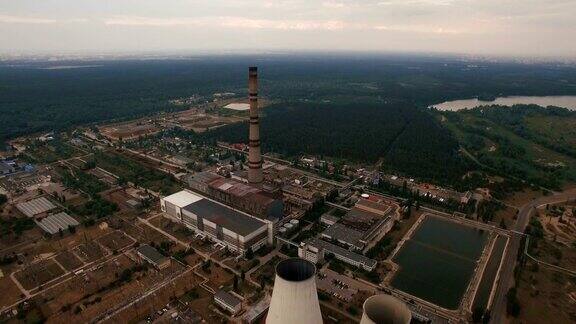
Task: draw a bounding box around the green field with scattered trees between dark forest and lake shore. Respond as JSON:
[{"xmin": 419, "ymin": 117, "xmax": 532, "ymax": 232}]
[{"xmin": 439, "ymin": 106, "xmax": 576, "ymax": 189}]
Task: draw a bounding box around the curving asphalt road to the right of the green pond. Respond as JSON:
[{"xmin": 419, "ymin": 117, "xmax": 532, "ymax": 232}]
[{"xmin": 491, "ymin": 189, "xmax": 576, "ymax": 324}]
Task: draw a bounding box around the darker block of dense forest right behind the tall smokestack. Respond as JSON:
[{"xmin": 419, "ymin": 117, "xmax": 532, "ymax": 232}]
[{"xmin": 204, "ymin": 100, "xmax": 466, "ymax": 182}]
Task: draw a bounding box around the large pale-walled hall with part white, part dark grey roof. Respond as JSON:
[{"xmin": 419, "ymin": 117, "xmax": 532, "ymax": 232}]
[{"xmin": 160, "ymin": 190, "xmax": 272, "ymax": 254}]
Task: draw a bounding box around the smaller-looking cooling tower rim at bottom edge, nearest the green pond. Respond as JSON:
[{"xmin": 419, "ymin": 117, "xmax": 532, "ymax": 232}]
[{"xmin": 360, "ymin": 295, "xmax": 412, "ymax": 324}]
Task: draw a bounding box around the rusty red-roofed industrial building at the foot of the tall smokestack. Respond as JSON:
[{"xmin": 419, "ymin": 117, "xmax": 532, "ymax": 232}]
[{"xmin": 186, "ymin": 172, "xmax": 284, "ymax": 221}]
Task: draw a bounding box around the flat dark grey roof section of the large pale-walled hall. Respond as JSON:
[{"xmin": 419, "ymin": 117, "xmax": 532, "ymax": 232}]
[{"xmin": 183, "ymin": 199, "xmax": 266, "ymax": 236}]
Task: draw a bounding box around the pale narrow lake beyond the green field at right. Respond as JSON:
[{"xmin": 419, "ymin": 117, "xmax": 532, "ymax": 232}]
[{"xmin": 431, "ymin": 96, "xmax": 576, "ymax": 111}]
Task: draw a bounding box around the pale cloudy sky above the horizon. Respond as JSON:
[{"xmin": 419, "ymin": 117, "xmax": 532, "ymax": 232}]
[{"xmin": 0, "ymin": 0, "xmax": 576, "ymax": 58}]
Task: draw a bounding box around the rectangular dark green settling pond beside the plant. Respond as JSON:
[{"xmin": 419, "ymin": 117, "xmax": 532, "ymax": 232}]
[{"xmin": 392, "ymin": 216, "xmax": 488, "ymax": 309}]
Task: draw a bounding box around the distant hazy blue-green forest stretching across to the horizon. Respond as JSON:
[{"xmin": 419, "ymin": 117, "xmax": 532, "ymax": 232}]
[{"xmin": 0, "ymin": 53, "xmax": 576, "ymax": 141}]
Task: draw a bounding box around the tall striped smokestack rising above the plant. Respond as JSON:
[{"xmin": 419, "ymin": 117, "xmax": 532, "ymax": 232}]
[{"xmin": 248, "ymin": 66, "xmax": 264, "ymax": 185}]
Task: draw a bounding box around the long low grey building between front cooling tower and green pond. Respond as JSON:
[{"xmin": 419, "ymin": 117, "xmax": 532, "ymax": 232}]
[{"xmin": 298, "ymin": 239, "xmax": 377, "ymax": 271}]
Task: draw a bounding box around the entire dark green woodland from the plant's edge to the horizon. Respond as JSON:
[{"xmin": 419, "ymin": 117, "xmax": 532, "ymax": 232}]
[{"xmin": 0, "ymin": 53, "xmax": 576, "ymax": 187}]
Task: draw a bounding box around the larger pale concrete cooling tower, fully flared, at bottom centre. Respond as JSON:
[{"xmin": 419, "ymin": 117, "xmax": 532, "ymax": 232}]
[{"xmin": 266, "ymin": 258, "xmax": 322, "ymax": 324}]
